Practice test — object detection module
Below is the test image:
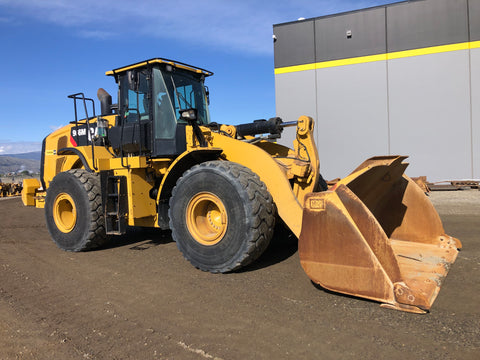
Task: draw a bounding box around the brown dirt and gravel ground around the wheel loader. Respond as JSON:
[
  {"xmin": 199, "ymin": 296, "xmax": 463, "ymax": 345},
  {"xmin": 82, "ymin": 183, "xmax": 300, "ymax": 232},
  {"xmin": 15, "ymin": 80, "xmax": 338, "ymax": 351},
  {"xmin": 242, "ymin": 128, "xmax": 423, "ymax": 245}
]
[{"xmin": 0, "ymin": 190, "xmax": 480, "ymax": 360}]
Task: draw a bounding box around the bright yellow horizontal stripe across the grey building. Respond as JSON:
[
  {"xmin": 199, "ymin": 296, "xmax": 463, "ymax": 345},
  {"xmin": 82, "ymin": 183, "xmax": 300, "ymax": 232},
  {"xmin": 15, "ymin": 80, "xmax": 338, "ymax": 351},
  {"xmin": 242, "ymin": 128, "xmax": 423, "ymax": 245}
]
[{"xmin": 275, "ymin": 41, "xmax": 480, "ymax": 75}]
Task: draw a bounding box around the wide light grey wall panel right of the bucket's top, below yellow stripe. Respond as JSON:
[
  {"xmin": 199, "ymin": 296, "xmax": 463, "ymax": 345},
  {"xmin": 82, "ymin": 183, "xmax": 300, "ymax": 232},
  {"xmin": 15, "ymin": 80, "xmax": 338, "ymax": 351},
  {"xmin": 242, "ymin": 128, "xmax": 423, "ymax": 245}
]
[{"xmin": 388, "ymin": 50, "xmax": 472, "ymax": 181}]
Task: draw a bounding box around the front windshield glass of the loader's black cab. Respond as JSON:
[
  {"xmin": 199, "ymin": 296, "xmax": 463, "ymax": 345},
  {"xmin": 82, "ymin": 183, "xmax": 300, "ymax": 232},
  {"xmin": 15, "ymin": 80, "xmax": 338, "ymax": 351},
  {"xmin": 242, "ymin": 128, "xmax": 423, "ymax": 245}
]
[{"xmin": 153, "ymin": 68, "xmax": 210, "ymax": 138}]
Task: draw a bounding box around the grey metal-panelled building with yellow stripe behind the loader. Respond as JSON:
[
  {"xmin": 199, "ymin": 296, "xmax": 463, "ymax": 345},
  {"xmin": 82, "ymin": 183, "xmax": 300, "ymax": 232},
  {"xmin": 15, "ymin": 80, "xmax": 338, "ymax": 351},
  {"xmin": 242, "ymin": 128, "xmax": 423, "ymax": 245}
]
[{"xmin": 273, "ymin": 0, "xmax": 480, "ymax": 181}]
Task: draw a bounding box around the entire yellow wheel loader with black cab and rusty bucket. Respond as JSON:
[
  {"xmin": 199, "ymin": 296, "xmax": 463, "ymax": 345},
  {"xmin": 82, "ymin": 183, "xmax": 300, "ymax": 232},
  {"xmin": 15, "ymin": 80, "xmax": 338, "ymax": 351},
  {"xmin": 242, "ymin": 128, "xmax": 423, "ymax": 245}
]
[{"xmin": 22, "ymin": 58, "xmax": 461, "ymax": 313}]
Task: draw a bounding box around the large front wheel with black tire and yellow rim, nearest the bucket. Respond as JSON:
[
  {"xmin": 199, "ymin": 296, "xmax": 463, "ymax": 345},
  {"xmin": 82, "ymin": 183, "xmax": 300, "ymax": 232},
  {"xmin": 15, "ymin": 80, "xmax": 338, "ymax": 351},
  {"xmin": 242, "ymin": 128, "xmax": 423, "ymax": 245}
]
[{"xmin": 169, "ymin": 161, "xmax": 275, "ymax": 273}]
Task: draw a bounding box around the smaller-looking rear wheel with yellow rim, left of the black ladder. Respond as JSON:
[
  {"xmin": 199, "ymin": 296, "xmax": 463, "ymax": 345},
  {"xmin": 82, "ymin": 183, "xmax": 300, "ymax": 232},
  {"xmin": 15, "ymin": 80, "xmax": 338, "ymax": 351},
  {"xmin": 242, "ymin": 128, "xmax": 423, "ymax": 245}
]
[{"xmin": 45, "ymin": 169, "xmax": 107, "ymax": 251}]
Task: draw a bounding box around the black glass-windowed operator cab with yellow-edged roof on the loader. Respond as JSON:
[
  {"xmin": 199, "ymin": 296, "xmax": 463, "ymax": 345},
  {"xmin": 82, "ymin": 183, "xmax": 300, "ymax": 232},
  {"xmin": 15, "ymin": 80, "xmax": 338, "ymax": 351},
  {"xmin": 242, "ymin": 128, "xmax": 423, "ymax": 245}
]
[{"xmin": 102, "ymin": 58, "xmax": 213, "ymax": 157}]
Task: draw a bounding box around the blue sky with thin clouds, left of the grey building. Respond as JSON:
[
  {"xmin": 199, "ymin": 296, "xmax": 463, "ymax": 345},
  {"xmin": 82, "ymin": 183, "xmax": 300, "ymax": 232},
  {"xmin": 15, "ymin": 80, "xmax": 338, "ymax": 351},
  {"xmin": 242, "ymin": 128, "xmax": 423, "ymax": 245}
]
[{"xmin": 0, "ymin": 0, "xmax": 394, "ymax": 154}]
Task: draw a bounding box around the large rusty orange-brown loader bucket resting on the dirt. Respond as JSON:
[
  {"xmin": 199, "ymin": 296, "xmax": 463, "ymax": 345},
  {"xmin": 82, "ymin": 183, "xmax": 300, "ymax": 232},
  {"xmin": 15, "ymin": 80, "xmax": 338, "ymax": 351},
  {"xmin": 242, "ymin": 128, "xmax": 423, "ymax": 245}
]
[{"xmin": 298, "ymin": 156, "xmax": 461, "ymax": 313}]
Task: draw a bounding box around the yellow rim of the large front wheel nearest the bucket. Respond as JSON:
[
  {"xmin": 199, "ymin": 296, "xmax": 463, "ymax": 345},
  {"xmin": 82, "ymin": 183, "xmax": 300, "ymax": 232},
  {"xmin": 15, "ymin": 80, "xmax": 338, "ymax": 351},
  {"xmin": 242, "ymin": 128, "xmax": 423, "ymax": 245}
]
[{"xmin": 186, "ymin": 192, "xmax": 228, "ymax": 246}]
